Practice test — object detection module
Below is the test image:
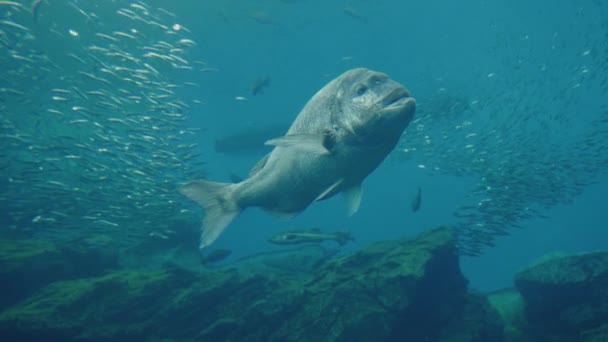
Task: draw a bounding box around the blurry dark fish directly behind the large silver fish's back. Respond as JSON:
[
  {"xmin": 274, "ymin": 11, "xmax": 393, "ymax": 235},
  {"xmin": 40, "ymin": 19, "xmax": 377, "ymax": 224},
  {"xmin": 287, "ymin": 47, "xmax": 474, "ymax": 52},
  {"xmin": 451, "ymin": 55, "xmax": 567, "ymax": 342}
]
[{"xmin": 215, "ymin": 123, "xmax": 289, "ymax": 154}]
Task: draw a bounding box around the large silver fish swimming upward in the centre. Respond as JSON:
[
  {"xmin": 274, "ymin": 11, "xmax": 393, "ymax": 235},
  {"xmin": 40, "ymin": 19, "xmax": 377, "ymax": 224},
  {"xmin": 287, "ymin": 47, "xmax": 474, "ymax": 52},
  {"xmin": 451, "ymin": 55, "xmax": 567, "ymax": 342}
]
[{"xmin": 180, "ymin": 68, "xmax": 416, "ymax": 248}]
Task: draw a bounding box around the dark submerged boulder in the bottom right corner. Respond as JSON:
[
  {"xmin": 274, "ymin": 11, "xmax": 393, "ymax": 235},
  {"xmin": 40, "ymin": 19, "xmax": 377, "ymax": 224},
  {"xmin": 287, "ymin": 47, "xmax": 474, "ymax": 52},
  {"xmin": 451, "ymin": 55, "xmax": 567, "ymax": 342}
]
[{"xmin": 515, "ymin": 252, "xmax": 608, "ymax": 341}]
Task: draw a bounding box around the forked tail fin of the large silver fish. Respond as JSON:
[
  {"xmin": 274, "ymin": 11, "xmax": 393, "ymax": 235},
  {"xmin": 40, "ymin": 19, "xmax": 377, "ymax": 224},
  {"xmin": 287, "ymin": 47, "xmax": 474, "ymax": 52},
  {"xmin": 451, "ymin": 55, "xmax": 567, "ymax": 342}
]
[{"xmin": 179, "ymin": 180, "xmax": 242, "ymax": 249}]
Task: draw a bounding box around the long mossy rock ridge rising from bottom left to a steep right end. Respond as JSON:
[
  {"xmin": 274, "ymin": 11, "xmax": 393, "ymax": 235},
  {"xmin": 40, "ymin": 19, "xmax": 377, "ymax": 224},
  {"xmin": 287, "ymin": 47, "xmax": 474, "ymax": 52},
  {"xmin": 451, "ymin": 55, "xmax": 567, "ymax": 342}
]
[{"xmin": 0, "ymin": 228, "xmax": 502, "ymax": 341}]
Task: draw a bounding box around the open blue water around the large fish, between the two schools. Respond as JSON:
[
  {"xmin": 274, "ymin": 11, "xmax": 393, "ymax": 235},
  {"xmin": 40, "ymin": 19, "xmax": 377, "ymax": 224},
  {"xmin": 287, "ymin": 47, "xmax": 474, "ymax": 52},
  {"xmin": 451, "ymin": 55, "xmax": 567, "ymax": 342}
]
[{"xmin": 172, "ymin": 1, "xmax": 608, "ymax": 290}]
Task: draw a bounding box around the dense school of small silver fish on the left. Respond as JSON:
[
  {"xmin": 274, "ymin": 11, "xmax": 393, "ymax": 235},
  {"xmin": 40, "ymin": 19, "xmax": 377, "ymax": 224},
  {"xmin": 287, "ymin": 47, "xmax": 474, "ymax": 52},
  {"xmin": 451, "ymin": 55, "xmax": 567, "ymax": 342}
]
[{"xmin": 0, "ymin": 0, "xmax": 205, "ymax": 247}]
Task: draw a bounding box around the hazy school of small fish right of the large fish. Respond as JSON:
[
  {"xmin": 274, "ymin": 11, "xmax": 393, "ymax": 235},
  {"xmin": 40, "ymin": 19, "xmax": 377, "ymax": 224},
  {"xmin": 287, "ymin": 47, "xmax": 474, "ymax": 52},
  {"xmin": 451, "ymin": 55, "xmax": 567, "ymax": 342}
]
[{"xmin": 393, "ymin": 2, "xmax": 608, "ymax": 256}]
